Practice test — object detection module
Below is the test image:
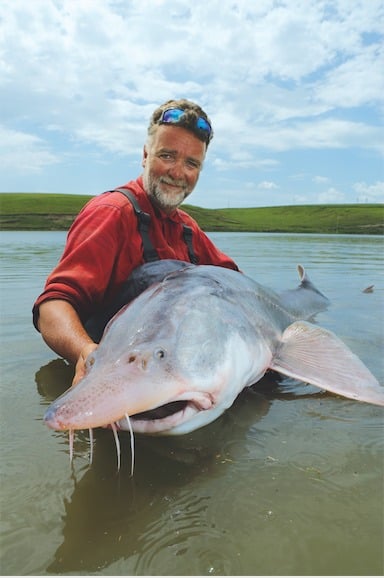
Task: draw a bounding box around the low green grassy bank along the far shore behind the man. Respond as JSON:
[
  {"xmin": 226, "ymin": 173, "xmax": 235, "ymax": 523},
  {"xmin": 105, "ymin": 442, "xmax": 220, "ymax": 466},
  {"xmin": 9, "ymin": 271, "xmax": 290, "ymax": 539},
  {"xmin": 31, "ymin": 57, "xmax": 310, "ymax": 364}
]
[{"xmin": 0, "ymin": 193, "xmax": 384, "ymax": 234}]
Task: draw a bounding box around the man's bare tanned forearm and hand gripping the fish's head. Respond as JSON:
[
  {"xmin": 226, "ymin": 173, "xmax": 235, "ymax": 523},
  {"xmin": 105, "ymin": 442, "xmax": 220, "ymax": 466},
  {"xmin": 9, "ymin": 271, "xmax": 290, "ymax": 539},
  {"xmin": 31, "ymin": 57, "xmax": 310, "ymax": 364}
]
[{"xmin": 38, "ymin": 299, "xmax": 97, "ymax": 385}]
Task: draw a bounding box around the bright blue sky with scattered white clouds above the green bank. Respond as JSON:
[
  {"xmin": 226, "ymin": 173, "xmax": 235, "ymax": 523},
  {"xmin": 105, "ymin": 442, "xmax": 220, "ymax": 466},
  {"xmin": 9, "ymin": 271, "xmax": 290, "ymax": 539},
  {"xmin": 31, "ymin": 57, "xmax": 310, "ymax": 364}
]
[{"xmin": 0, "ymin": 0, "xmax": 384, "ymax": 208}]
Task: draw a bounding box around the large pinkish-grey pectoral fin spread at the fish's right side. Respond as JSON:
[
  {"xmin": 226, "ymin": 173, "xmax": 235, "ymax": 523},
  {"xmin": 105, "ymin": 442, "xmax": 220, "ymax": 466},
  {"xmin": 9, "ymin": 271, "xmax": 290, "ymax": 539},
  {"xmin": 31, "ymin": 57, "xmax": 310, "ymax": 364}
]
[{"xmin": 270, "ymin": 321, "xmax": 384, "ymax": 405}]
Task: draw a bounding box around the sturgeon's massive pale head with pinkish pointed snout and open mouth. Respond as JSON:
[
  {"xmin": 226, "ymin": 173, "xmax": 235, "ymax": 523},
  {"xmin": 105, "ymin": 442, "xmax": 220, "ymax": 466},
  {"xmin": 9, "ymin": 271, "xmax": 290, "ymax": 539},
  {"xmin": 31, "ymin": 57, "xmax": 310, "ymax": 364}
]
[{"xmin": 45, "ymin": 272, "xmax": 271, "ymax": 435}]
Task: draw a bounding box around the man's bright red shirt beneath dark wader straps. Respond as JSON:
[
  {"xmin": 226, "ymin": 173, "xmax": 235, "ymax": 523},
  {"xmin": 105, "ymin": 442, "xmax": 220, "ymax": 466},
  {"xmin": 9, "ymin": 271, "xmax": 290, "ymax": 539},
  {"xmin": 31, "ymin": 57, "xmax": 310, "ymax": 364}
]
[{"xmin": 33, "ymin": 177, "xmax": 238, "ymax": 325}]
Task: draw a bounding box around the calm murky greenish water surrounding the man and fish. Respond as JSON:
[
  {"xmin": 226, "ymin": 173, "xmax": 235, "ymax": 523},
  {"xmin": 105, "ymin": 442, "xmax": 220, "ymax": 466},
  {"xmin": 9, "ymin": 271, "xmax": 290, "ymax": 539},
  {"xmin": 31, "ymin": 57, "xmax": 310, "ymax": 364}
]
[{"xmin": 1, "ymin": 232, "xmax": 384, "ymax": 575}]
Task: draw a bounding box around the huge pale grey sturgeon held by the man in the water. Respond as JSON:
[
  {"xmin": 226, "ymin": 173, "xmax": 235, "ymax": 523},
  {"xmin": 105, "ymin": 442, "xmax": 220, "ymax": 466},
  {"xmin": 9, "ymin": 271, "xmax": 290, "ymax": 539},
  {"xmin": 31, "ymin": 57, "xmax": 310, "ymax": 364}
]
[{"xmin": 44, "ymin": 261, "xmax": 384, "ymax": 435}]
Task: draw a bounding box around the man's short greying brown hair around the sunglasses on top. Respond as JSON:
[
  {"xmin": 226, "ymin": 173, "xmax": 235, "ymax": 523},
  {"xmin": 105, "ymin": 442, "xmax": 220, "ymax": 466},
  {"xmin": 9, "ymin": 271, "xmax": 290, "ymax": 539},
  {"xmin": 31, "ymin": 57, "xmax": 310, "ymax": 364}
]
[{"xmin": 148, "ymin": 98, "xmax": 213, "ymax": 148}]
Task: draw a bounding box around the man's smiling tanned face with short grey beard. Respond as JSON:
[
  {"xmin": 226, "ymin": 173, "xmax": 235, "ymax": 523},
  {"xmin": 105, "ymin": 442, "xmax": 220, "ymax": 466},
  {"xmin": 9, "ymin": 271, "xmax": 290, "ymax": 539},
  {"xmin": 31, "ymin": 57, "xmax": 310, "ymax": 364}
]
[{"xmin": 142, "ymin": 125, "xmax": 206, "ymax": 213}]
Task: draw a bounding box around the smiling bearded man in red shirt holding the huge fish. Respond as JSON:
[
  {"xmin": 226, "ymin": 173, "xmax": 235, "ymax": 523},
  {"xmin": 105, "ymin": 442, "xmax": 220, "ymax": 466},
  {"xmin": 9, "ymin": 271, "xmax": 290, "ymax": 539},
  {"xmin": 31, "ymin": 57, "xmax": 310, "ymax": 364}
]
[{"xmin": 33, "ymin": 99, "xmax": 238, "ymax": 384}]
